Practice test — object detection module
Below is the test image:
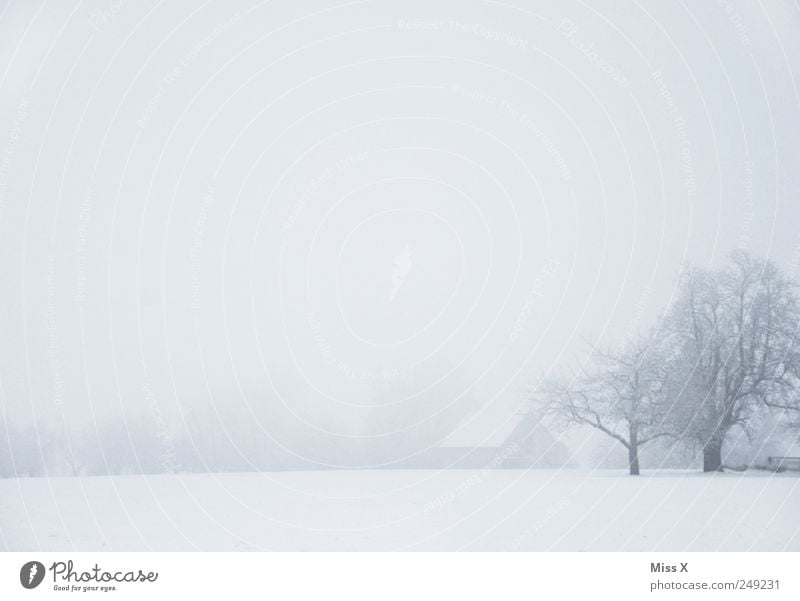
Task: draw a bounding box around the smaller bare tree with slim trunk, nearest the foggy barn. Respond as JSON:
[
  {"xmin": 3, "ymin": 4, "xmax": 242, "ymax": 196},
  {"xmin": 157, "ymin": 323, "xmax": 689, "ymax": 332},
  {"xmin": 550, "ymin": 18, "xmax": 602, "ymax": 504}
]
[{"xmin": 538, "ymin": 335, "xmax": 671, "ymax": 475}]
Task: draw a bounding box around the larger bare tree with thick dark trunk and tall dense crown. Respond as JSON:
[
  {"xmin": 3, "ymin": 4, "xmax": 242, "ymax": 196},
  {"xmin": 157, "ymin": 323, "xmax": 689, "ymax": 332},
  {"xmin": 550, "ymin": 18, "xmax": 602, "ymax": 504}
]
[{"xmin": 668, "ymin": 251, "xmax": 800, "ymax": 472}]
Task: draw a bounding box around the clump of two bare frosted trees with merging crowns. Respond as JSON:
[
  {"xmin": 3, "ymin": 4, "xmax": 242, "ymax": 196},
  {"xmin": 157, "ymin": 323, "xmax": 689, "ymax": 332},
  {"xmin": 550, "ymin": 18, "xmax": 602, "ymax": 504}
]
[{"xmin": 533, "ymin": 251, "xmax": 800, "ymax": 475}]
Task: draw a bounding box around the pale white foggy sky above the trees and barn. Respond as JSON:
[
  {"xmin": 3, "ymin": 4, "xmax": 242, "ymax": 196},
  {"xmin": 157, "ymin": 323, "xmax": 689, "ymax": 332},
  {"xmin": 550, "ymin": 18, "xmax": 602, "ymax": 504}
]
[{"xmin": 0, "ymin": 0, "xmax": 800, "ymax": 454}]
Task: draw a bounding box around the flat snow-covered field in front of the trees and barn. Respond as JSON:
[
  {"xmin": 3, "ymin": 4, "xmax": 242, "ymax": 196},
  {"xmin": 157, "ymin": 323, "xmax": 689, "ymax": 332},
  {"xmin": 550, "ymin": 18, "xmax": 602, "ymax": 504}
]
[{"xmin": 0, "ymin": 470, "xmax": 800, "ymax": 551}]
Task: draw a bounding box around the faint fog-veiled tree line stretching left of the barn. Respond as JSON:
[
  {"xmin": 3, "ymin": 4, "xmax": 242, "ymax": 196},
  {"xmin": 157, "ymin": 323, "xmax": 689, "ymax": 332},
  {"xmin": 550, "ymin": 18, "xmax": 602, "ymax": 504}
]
[{"xmin": 0, "ymin": 372, "xmax": 476, "ymax": 477}]
